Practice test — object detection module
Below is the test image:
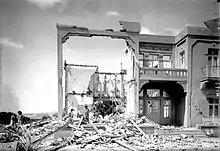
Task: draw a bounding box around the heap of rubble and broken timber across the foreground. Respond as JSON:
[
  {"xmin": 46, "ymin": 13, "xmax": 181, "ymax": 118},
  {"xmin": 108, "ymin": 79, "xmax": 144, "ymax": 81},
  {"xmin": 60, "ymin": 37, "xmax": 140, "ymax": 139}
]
[{"xmin": 0, "ymin": 115, "xmax": 220, "ymax": 151}]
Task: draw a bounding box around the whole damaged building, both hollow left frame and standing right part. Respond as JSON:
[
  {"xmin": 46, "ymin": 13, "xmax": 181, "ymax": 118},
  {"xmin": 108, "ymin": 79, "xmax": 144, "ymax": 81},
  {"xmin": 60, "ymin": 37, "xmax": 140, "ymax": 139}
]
[{"xmin": 57, "ymin": 18, "xmax": 220, "ymax": 126}]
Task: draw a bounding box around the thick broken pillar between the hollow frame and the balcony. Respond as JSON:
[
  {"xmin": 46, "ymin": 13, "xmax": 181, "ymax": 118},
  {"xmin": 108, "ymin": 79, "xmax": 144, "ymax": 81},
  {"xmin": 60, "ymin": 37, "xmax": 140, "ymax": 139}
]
[{"xmin": 120, "ymin": 21, "xmax": 140, "ymax": 115}]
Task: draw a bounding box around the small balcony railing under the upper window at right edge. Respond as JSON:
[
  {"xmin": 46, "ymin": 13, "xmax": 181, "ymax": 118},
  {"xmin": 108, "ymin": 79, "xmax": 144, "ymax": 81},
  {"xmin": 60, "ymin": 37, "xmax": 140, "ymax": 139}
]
[{"xmin": 202, "ymin": 66, "xmax": 220, "ymax": 77}]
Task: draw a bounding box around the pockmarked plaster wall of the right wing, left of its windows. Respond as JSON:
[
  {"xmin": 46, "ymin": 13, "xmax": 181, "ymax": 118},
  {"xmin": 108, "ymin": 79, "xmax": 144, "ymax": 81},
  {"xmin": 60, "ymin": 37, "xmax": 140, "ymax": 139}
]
[{"xmin": 188, "ymin": 38, "xmax": 219, "ymax": 126}]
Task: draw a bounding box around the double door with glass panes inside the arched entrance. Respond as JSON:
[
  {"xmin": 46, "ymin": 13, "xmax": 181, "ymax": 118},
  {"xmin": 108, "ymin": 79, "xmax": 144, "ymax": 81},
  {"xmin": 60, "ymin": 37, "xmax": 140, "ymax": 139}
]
[{"xmin": 144, "ymin": 97, "xmax": 173, "ymax": 125}]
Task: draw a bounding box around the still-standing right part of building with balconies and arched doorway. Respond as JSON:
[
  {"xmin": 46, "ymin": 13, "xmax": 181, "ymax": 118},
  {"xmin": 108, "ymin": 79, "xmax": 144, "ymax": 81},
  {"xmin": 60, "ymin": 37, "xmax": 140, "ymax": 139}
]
[{"xmin": 139, "ymin": 19, "xmax": 220, "ymax": 126}]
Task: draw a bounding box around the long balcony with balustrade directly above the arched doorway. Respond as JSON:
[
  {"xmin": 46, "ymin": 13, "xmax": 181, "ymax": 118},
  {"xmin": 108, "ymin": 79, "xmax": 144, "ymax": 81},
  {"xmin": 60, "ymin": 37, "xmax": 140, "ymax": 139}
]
[{"xmin": 140, "ymin": 67, "xmax": 187, "ymax": 81}]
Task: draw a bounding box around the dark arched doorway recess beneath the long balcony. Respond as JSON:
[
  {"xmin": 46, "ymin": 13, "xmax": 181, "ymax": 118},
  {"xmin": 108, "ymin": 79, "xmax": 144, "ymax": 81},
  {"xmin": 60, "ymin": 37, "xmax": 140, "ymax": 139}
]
[{"xmin": 142, "ymin": 81, "xmax": 186, "ymax": 126}]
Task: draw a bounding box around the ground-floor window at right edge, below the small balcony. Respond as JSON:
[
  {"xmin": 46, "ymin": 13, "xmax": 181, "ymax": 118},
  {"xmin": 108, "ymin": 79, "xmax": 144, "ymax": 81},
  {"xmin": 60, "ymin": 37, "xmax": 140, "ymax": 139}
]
[{"xmin": 208, "ymin": 98, "xmax": 219, "ymax": 116}]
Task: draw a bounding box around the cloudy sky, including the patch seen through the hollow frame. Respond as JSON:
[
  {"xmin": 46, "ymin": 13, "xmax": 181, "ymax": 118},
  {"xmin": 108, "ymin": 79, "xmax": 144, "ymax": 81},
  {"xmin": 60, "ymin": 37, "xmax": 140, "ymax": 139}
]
[{"xmin": 0, "ymin": 0, "xmax": 218, "ymax": 113}]
